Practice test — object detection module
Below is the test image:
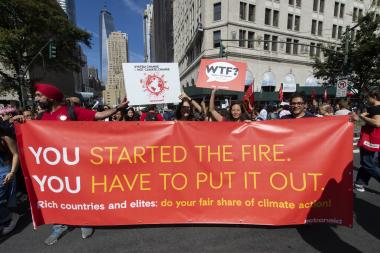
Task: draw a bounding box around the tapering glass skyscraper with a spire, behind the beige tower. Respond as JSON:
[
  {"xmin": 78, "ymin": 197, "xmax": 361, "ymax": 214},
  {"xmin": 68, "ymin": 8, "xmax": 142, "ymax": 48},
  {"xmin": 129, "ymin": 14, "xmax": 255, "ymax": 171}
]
[{"xmin": 99, "ymin": 6, "xmax": 115, "ymax": 85}]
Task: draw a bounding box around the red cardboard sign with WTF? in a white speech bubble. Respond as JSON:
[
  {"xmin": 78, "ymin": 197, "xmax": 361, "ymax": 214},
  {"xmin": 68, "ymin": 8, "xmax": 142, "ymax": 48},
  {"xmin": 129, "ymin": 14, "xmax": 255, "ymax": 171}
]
[{"xmin": 196, "ymin": 59, "xmax": 247, "ymax": 91}]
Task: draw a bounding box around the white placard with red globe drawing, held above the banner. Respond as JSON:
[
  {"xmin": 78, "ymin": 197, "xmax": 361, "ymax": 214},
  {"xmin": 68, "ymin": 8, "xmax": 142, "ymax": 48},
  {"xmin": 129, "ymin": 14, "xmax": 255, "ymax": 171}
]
[{"xmin": 123, "ymin": 63, "xmax": 181, "ymax": 105}]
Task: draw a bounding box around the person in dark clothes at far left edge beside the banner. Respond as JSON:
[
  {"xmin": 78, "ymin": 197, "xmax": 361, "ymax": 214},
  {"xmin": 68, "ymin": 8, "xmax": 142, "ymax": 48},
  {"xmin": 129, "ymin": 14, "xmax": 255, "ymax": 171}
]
[{"xmin": 0, "ymin": 122, "xmax": 20, "ymax": 235}]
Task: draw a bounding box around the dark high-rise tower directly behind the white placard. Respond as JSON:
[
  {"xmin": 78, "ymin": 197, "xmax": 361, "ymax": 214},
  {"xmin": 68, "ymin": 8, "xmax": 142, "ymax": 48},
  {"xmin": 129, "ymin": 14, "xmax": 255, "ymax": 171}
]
[{"xmin": 153, "ymin": 0, "xmax": 174, "ymax": 62}]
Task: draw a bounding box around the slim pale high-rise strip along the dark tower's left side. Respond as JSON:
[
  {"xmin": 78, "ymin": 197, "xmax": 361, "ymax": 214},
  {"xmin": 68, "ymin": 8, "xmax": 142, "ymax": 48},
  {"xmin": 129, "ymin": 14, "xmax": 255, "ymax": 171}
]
[{"xmin": 143, "ymin": 4, "xmax": 154, "ymax": 62}]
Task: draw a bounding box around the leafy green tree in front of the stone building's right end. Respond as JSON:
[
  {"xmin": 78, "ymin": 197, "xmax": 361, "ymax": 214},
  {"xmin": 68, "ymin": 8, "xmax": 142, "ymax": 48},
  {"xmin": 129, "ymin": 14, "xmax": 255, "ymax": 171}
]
[{"xmin": 313, "ymin": 12, "xmax": 380, "ymax": 94}]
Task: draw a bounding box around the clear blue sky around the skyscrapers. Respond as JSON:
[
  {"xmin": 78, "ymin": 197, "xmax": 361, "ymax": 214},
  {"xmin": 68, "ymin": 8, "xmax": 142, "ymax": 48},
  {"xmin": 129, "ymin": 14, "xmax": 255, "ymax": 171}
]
[{"xmin": 75, "ymin": 0, "xmax": 152, "ymax": 71}]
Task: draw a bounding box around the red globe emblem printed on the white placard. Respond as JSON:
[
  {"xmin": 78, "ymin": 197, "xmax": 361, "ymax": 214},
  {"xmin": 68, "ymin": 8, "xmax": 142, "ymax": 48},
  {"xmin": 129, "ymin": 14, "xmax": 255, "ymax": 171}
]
[{"xmin": 140, "ymin": 74, "xmax": 169, "ymax": 101}]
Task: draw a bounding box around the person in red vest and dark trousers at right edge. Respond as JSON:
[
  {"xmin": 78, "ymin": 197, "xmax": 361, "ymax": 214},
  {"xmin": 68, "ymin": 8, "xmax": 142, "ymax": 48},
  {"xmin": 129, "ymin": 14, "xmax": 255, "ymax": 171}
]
[{"xmin": 352, "ymin": 90, "xmax": 380, "ymax": 192}]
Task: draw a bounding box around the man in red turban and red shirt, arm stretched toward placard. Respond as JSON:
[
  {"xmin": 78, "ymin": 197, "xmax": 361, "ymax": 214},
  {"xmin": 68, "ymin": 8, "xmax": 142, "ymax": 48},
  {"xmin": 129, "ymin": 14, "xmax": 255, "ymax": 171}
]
[{"xmin": 35, "ymin": 83, "xmax": 128, "ymax": 245}]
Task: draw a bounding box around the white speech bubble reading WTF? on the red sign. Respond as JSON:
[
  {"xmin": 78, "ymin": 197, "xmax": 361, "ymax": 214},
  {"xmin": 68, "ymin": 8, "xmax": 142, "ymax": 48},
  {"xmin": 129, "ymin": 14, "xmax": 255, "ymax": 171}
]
[{"xmin": 206, "ymin": 62, "xmax": 239, "ymax": 83}]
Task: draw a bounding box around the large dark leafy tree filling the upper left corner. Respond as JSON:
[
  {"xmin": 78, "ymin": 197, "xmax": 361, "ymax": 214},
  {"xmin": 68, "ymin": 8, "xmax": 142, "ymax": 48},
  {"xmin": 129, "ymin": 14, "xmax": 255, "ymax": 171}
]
[{"xmin": 0, "ymin": 0, "xmax": 91, "ymax": 103}]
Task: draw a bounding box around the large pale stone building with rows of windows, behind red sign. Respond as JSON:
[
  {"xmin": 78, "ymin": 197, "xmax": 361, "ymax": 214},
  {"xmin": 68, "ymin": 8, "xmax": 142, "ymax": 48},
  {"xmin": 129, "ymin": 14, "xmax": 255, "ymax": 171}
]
[{"xmin": 173, "ymin": 0, "xmax": 379, "ymax": 96}]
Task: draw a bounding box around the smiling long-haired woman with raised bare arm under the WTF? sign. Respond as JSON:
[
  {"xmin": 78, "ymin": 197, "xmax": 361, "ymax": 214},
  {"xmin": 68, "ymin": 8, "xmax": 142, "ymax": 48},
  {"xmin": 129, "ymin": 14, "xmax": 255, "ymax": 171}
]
[{"xmin": 209, "ymin": 89, "xmax": 248, "ymax": 122}]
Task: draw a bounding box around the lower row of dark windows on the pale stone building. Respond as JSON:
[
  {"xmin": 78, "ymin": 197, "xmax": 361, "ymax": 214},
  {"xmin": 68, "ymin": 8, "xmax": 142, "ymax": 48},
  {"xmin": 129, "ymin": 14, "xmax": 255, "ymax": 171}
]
[{"xmin": 214, "ymin": 29, "xmax": 322, "ymax": 57}]
